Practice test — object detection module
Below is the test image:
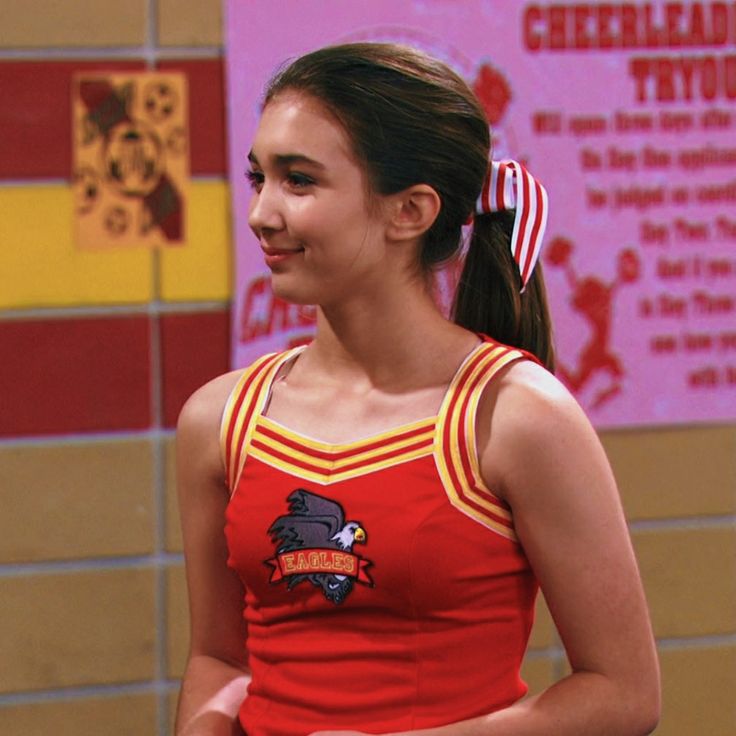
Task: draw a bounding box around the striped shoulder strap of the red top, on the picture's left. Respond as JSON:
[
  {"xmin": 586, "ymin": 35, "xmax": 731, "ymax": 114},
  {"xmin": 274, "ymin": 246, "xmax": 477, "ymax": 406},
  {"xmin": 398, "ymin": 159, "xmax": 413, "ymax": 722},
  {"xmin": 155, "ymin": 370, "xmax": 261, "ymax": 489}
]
[{"xmin": 220, "ymin": 348, "xmax": 301, "ymax": 495}]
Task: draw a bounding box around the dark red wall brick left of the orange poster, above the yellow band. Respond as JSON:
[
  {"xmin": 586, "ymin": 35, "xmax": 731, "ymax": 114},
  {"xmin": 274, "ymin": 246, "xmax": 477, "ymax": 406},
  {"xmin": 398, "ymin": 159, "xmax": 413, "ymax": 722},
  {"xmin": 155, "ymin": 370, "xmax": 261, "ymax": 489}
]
[{"xmin": 0, "ymin": 61, "xmax": 145, "ymax": 179}]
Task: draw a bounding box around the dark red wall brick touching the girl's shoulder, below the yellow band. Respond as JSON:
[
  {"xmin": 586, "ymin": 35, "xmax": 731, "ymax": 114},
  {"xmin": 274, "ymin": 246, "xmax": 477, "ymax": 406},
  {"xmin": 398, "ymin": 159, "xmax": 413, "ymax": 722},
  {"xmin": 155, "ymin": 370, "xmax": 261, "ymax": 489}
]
[{"xmin": 161, "ymin": 311, "xmax": 230, "ymax": 427}]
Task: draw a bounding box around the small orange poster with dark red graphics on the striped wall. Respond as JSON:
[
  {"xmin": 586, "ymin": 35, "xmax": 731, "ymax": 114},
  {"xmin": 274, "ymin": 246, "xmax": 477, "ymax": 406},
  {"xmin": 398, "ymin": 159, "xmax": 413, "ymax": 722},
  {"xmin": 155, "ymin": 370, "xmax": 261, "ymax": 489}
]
[{"xmin": 72, "ymin": 72, "xmax": 189, "ymax": 248}]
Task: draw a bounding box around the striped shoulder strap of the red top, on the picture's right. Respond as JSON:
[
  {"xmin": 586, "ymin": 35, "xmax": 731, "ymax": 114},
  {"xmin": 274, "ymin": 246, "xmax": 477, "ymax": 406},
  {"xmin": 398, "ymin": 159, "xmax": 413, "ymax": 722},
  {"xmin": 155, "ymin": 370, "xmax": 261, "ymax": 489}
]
[{"xmin": 435, "ymin": 338, "xmax": 529, "ymax": 541}]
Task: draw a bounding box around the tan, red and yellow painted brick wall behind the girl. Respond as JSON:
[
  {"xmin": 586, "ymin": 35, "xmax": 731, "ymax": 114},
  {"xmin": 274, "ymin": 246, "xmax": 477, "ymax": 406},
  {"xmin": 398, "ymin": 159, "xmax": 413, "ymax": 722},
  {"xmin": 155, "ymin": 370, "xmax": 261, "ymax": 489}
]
[{"xmin": 0, "ymin": 0, "xmax": 736, "ymax": 736}]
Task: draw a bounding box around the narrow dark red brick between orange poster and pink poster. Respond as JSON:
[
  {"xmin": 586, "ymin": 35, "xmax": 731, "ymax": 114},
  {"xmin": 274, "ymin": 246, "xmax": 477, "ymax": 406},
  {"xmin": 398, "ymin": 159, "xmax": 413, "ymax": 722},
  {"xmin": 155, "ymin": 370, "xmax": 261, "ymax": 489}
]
[{"xmin": 157, "ymin": 59, "xmax": 227, "ymax": 175}]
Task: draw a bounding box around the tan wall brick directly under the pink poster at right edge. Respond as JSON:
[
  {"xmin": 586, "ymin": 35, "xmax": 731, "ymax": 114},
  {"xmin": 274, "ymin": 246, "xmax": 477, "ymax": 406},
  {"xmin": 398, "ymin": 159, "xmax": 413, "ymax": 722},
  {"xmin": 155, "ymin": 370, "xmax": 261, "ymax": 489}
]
[{"xmin": 601, "ymin": 426, "xmax": 736, "ymax": 519}]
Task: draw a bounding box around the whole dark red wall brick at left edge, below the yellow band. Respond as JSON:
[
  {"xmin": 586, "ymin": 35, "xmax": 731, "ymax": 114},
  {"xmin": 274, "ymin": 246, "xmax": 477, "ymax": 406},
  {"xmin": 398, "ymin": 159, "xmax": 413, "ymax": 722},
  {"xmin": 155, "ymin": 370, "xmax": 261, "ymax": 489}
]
[{"xmin": 0, "ymin": 316, "xmax": 151, "ymax": 437}]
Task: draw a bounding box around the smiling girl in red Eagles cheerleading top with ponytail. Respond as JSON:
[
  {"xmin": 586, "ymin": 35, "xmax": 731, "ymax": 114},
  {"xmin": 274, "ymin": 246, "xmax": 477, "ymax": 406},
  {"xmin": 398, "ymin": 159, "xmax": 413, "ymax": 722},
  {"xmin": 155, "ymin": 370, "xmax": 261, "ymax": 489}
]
[{"xmin": 177, "ymin": 44, "xmax": 659, "ymax": 736}]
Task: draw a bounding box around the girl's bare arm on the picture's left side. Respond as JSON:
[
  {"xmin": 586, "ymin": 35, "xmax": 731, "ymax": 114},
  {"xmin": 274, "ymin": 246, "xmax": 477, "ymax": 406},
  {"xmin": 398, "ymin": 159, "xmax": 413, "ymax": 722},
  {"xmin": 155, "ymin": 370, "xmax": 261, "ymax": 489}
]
[{"xmin": 175, "ymin": 373, "xmax": 249, "ymax": 736}]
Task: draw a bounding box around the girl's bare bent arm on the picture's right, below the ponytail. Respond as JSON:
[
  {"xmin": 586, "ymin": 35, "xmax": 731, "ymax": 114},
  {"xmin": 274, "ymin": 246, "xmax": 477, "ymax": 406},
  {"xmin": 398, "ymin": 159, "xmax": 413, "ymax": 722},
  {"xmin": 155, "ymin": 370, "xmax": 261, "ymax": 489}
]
[{"xmin": 310, "ymin": 362, "xmax": 660, "ymax": 736}]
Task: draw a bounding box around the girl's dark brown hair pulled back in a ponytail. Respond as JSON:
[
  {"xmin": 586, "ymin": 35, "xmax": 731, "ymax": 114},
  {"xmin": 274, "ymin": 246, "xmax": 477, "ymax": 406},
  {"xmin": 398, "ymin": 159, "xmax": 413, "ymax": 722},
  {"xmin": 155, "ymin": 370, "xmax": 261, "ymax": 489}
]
[{"xmin": 264, "ymin": 43, "xmax": 554, "ymax": 368}]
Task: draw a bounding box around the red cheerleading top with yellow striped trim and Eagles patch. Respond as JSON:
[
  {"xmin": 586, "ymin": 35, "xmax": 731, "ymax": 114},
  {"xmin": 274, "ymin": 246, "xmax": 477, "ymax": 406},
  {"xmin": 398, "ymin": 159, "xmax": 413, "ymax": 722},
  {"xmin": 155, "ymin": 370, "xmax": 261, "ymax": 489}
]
[{"xmin": 222, "ymin": 341, "xmax": 537, "ymax": 736}]
